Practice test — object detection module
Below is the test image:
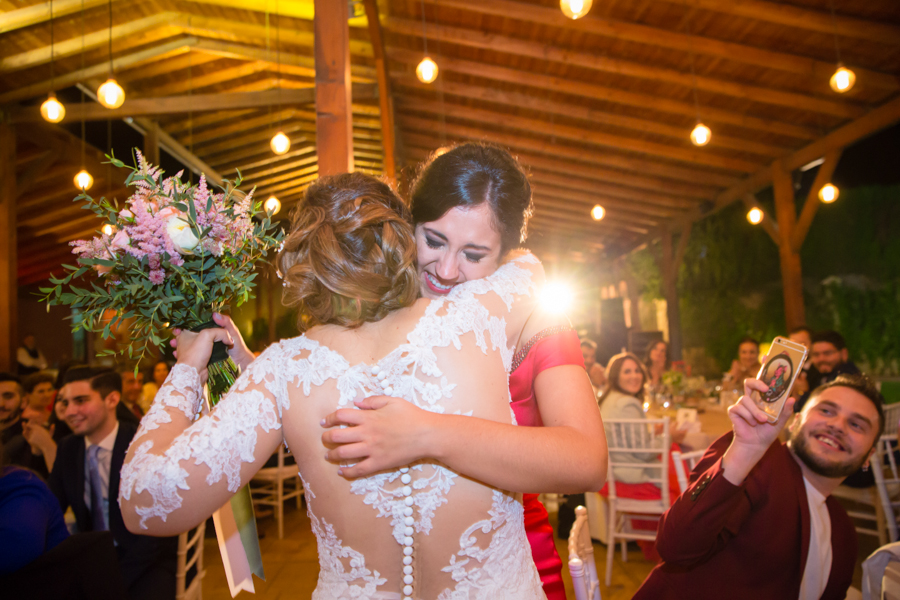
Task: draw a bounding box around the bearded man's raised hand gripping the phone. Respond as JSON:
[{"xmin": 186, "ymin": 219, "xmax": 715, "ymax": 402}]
[{"xmin": 722, "ymin": 379, "xmax": 796, "ymax": 485}]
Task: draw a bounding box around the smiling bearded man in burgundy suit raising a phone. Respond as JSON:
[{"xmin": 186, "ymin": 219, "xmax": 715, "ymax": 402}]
[{"xmin": 634, "ymin": 375, "xmax": 884, "ymax": 600}]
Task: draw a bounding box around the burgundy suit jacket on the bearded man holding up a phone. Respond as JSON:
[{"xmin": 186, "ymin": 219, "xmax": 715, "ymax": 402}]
[{"xmin": 634, "ymin": 433, "xmax": 857, "ymax": 600}]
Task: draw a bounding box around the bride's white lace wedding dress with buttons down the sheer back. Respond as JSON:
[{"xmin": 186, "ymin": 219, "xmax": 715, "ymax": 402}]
[{"xmin": 120, "ymin": 255, "xmax": 545, "ymax": 600}]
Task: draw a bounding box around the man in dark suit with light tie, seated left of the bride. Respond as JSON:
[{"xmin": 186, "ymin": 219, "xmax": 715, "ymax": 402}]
[{"xmin": 49, "ymin": 367, "xmax": 178, "ymax": 600}]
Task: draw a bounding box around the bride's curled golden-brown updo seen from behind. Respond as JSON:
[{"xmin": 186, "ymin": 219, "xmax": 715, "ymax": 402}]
[{"xmin": 275, "ymin": 173, "xmax": 419, "ymax": 331}]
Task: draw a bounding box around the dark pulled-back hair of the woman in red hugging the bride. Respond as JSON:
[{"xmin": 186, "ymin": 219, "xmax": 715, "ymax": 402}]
[{"xmin": 410, "ymin": 142, "xmax": 534, "ymax": 255}]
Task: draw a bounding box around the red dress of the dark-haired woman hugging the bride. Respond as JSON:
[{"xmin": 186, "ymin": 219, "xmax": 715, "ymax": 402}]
[{"xmin": 509, "ymin": 326, "xmax": 584, "ymax": 600}]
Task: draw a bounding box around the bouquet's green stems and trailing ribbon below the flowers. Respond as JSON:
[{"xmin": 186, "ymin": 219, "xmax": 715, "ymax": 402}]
[{"xmin": 193, "ymin": 321, "xmax": 266, "ymax": 598}]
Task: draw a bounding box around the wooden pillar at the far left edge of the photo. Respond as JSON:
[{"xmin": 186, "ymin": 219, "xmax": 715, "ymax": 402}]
[{"xmin": 0, "ymin": 122, "xmax": 19, "ymax": 372}]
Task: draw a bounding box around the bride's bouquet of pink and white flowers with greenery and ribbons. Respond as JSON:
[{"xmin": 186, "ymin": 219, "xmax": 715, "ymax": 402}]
[{"xmin": 41, "ymin": 151, "xmax": 284, "ymax": 594}]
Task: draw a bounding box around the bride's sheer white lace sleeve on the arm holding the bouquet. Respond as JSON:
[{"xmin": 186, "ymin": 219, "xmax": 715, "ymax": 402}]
[{"xmin": 119, "ymin": 352, "xmax": 286, "ymax": 535}]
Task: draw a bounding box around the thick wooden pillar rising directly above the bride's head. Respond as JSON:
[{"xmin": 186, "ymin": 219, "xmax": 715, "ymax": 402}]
[{"xmin": 314, "ymin": 0, "xmax": 353, "ymax": 176}]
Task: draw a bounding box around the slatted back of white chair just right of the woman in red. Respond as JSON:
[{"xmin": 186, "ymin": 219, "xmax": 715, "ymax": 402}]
[{"xmin": 603, "ymin": 417, "xmax": 671, "ymax": 508}]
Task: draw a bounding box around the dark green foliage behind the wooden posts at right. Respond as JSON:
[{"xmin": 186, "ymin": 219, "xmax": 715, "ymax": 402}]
[{"xmin": 627, "ymin": 186, "xmax": 900, "ymax": 375}]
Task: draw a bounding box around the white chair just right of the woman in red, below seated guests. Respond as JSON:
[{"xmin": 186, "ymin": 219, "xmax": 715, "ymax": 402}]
[{"xmin": 604, "ymin": 417, "xmax": 671, "ymax": 587}]
